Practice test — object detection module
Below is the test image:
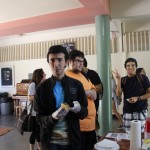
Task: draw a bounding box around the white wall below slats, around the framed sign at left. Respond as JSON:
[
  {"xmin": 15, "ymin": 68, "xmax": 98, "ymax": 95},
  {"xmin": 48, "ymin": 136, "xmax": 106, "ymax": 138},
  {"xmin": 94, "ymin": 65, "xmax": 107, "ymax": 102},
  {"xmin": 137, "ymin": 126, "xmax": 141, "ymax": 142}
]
[{"xmin": 0, "ymin": 59, "xmax": 51, "ymax": 95}]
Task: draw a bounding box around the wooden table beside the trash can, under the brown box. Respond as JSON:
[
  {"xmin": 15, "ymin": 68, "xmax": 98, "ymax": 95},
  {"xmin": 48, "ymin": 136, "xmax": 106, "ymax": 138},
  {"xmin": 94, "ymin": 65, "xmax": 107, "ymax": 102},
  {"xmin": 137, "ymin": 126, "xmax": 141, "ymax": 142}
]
[{"xmin": 12, "ymin": 95, "xmax": 28, "ymax": 117}]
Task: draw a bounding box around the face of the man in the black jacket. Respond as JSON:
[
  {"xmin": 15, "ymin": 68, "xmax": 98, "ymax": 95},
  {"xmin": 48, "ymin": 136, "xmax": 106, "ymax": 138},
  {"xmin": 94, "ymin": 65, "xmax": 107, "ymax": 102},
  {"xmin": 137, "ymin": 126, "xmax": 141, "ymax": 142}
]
[{"xmin": 49, "ymin": 53, "xmax": 67, "ymax": 79}]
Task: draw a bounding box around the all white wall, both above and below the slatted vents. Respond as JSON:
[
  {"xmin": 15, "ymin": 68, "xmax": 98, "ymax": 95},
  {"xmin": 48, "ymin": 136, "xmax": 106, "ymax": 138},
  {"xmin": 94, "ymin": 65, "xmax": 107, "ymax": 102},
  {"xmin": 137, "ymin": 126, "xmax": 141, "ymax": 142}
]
[{"xmin": 0, "ymin": 25, "xmax": 150, "ymax": 115}]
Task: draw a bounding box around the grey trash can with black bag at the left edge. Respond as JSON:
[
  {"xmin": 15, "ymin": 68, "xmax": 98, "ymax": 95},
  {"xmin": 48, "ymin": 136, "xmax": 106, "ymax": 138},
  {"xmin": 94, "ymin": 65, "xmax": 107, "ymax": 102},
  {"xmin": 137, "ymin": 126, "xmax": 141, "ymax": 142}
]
[{"xmin": 0, "ymin": 97, "xmax": 13, "ymax": 115}]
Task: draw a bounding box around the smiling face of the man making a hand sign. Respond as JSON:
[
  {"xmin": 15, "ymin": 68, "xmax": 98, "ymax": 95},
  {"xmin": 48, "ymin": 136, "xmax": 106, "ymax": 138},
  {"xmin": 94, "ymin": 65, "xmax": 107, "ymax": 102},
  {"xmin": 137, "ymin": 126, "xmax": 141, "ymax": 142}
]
[{"xmin": 126, "ymin": 61, "xmax": 136, "ymax": 76}]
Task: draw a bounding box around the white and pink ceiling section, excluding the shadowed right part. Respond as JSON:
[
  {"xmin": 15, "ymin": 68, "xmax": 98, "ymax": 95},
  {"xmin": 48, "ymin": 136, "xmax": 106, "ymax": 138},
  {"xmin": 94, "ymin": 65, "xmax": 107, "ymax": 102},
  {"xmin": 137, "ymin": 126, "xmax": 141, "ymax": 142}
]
[{"xmin": 0, "ymin": 0, "xmax": 110, "ymax": 37}]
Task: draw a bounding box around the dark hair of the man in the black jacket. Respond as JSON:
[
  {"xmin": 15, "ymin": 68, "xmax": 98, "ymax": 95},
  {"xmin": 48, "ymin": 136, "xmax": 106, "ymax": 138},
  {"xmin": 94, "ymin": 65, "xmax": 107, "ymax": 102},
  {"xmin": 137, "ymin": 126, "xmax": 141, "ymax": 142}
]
[{"xmin": 47, "ymin": 45, "xmax": 68, "ymax": 63}]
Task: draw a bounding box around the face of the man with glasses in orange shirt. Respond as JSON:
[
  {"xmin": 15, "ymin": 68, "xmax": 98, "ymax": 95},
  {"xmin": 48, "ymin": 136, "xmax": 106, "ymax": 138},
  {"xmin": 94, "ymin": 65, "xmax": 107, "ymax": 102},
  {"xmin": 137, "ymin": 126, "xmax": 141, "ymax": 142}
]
[{"xmin": 70, "ymin": 57, "xmax": 84, "ymax": 72}]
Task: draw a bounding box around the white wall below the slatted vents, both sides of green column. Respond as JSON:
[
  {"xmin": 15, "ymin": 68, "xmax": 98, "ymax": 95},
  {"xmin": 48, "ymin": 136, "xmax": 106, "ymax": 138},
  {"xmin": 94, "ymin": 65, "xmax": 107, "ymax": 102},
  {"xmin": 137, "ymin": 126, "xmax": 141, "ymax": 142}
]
[{"xmin": 0, "ymin": 46, "xmax": 150, "ymax": 114}]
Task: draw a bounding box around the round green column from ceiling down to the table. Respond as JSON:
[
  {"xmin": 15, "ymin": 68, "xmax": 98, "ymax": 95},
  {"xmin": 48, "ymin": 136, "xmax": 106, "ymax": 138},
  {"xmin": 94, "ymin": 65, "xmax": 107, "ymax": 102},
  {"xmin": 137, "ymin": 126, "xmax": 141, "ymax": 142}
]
[{"xmin": 95, "ymin": 15, "xmax": 112, "ymax": 136}]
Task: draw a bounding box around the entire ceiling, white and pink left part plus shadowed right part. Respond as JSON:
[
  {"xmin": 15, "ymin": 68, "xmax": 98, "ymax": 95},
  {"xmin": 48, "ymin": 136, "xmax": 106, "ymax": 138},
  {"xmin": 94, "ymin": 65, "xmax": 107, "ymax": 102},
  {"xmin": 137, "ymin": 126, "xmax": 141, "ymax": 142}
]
[{"xmin": 0, "ymin": 0, "xmax": 150, "ymax": 38}]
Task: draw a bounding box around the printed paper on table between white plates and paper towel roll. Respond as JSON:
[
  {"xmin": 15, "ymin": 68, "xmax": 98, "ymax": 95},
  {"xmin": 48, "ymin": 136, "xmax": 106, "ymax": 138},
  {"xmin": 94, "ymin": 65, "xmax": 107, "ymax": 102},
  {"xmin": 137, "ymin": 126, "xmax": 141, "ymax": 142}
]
[{"xmin": 106, "ymin": 133, "xmax": 130, "ymax": 140}]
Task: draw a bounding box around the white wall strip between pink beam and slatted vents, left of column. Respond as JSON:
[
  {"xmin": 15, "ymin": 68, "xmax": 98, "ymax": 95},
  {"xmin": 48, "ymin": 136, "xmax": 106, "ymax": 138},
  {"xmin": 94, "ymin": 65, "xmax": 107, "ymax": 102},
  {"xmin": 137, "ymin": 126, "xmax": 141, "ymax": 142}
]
[{"xmin": 0, "ymin": 24, "xmax": 95, "ymax": 46}]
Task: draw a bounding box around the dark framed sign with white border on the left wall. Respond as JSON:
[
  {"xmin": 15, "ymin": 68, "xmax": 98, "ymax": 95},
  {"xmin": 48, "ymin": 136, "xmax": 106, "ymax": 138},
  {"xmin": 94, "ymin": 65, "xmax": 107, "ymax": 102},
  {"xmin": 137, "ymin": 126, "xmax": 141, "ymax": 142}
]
[{"xmin": 0, "ymin": 66, "xmax": 14, "ymax": 87}]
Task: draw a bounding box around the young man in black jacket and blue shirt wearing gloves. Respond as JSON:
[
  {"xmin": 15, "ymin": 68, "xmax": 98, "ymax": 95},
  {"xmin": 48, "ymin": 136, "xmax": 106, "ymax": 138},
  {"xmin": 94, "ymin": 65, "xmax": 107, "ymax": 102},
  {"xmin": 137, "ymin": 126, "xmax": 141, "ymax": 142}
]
[{"xmin": 34, "ymin": 45, "xmax": 87, "ymax": 150}]
